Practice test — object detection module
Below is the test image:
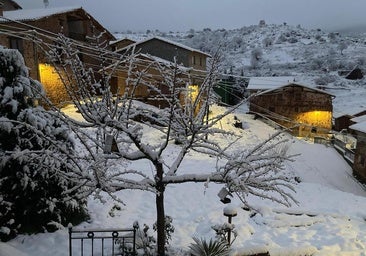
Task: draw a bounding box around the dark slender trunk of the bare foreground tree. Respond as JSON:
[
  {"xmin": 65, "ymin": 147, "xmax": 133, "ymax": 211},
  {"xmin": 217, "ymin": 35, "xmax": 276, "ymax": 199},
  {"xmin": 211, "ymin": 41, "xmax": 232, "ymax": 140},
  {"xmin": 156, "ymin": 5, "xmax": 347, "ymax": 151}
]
[{"xmin": 156, "ymin": 163, "xmax": 166, "ymax": 256}]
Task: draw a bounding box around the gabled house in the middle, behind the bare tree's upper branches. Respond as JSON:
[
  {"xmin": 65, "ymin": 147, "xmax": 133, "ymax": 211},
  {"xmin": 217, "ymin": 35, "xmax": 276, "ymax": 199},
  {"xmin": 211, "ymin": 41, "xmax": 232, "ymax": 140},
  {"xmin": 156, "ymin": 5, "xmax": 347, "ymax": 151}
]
[{"xmin": 111, "ymin": 37, "xmax": 211, "ymax": 108}]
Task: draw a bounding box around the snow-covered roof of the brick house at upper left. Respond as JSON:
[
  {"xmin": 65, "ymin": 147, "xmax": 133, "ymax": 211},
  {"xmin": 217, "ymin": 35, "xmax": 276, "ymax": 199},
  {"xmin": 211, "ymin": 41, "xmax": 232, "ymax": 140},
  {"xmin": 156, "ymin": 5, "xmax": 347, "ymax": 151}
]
[{"xmin": 1, "ymin": 6, "xmax": 81, "ymax": 21}]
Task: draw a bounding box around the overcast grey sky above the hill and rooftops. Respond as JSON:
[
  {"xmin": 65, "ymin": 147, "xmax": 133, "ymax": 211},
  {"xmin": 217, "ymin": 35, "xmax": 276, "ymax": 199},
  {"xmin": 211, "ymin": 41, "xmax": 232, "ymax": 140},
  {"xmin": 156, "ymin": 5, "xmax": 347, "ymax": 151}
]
[{"xmin": 15, "ymin": 0, "xmax": 366, "ymax": 32}]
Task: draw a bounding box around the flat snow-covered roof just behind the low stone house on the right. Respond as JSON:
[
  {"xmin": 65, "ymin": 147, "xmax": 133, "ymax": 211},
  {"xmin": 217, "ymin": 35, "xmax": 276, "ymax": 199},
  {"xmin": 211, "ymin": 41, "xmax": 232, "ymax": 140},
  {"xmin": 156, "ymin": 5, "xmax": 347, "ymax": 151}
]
[{"xmin": 247, "ymin": 76, "xmax": 296, "ymax": 90}]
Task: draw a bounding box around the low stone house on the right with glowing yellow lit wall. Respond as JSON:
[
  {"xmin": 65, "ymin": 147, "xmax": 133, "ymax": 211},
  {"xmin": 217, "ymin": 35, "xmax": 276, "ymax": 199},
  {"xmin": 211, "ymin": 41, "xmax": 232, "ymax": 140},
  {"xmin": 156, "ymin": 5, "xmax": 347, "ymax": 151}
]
[{"xmin": 249, "ymin": 83, "xmax": 334, "ymax": 137}]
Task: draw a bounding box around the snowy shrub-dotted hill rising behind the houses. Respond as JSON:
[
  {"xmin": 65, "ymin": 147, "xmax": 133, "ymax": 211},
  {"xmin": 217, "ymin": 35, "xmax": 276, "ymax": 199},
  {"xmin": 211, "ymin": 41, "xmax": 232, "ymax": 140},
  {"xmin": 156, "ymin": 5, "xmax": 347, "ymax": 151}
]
[{"xmin": 119, "ymin": 24, "xmax": 366, "ymax": 86}]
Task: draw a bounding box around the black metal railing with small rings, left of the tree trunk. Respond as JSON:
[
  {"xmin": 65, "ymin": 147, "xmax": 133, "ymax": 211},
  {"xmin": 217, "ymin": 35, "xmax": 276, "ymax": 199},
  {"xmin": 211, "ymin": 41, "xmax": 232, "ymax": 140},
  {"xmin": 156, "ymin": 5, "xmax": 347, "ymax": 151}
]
[{"xmin": 69, "ymin": 226, "xmax": 137, "ymax": 256}]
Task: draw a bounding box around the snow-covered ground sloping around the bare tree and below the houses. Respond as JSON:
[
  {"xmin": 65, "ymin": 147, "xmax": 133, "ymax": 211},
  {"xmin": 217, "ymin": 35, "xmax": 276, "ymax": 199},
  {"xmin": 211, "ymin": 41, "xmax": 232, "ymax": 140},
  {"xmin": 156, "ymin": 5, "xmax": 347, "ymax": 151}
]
[{"xmin": 0, "ymin": 99, "xmax": 366, "ymax": 256}]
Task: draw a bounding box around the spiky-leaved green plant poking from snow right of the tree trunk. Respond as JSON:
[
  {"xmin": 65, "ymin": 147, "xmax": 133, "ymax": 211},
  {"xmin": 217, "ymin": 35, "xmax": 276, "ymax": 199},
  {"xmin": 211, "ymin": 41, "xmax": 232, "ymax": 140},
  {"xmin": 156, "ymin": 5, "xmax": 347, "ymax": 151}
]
[{"xmin": 189, "ymin": 237, "xmax": 230, "ymax": 256}]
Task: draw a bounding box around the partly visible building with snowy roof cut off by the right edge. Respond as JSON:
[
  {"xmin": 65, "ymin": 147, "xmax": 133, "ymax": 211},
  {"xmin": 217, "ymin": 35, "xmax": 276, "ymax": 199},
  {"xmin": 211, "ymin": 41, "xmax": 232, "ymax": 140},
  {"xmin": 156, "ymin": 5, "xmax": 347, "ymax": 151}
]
[{"xmin": 349, "ymin": 121, "xmax": 366, "ymax": 182}]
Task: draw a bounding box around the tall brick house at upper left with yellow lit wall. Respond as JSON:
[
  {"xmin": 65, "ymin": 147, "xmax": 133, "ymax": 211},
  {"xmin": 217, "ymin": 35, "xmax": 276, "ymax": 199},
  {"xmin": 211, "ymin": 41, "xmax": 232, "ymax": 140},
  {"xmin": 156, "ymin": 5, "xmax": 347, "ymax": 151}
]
[{"xmin": 0, "ymin": 1, "xmax": 115, "ymax": 104}]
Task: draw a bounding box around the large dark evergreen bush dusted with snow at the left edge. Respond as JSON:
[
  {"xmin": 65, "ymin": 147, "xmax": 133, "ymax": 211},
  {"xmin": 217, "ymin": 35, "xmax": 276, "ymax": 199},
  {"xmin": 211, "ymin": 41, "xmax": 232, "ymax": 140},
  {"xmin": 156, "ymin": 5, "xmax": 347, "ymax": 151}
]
[{"xmin": 0, "ymin": 49, "xmax": 86, "ymax": 241}]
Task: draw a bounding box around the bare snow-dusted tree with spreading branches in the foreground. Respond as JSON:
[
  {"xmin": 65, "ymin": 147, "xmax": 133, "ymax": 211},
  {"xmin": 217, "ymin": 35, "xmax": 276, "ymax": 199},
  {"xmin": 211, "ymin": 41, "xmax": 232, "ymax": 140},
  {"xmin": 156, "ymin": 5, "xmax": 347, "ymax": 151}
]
[{"xmin": 30, "ymin": 35, "xmax": 295, "ymax": 255}]
